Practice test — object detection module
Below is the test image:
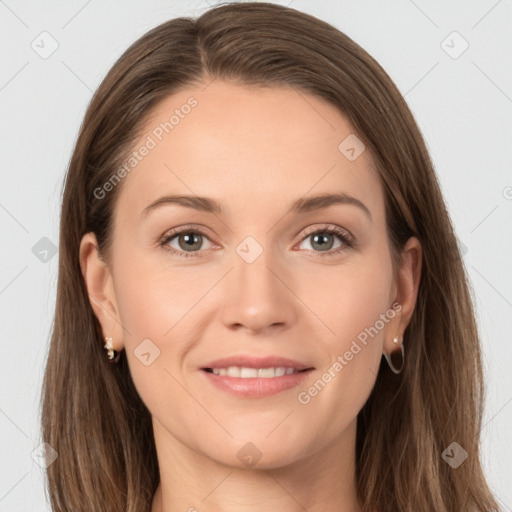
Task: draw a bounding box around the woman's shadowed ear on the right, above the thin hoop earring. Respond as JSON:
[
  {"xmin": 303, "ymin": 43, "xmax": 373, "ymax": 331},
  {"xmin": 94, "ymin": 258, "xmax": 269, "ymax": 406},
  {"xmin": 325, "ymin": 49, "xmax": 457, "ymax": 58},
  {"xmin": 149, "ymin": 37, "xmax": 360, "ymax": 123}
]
[{"xmin": 383, "ymin": 237, "xmax": 422, "ymax": 353}]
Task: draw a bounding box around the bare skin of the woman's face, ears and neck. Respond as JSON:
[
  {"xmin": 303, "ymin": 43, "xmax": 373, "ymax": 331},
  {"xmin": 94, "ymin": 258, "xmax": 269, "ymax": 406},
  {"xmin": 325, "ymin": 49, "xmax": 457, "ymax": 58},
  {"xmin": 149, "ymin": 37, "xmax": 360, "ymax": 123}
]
[{"xmin": 80, "ymin": 80, "xmax": 421, "ymax": 512}]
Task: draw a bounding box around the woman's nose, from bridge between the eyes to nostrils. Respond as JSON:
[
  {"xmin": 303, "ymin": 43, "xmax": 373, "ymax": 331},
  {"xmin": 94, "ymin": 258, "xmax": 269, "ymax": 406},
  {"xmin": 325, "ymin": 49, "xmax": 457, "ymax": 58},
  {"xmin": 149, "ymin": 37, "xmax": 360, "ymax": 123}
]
[{"xmin": 222, "ymin": 241, "xmax": 300, "ymax": 335}]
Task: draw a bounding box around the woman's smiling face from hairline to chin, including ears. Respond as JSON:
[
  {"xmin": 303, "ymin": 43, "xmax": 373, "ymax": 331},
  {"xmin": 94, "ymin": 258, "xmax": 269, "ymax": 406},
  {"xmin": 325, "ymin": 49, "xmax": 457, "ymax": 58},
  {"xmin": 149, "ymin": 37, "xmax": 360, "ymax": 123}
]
[{"xmin": 82, "ymin": 80, "xmax": 415, "ymax": 468}]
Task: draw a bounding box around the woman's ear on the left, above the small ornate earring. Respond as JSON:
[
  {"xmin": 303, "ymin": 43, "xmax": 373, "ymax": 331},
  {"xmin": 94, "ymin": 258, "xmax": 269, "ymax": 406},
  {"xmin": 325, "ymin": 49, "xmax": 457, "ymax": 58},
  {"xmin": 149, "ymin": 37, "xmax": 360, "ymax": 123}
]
[{"xmin": 80, "ymin": 232, "xmax": 124, "ymax": 352}]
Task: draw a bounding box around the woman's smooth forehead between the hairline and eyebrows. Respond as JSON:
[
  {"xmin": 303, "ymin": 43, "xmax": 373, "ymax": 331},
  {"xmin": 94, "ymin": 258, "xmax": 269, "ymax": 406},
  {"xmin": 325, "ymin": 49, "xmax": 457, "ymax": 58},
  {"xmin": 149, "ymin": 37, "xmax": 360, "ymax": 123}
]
[{"xmin": 113, "ymin": 80, "xmax": 383, "ymax": 224}]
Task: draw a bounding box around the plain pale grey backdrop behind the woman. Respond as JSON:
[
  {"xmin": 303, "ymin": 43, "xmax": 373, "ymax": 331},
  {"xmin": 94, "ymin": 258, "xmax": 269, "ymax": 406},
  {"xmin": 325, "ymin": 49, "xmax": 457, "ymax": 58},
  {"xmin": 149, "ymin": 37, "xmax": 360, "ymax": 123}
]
[{"xmin": 0, "ymin": 0, "xmax": 512, "ymax": 512}]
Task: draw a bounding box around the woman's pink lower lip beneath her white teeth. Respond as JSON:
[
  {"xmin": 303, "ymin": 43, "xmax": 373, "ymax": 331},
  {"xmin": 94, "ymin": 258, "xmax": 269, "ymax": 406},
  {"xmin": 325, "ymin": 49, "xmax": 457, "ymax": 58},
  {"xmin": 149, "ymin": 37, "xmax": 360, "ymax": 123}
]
[{"xmin": 201, "ymin": 369, "xmax": 313, "ymax": 398}]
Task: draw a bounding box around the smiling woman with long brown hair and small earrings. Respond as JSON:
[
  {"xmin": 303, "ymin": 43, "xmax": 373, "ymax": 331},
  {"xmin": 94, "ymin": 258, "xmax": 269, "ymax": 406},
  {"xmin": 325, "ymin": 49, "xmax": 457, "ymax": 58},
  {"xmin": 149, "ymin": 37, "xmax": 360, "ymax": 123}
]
[{"xmin": 42, "ymin": 3, "xmax": 498, "ymax": 512}]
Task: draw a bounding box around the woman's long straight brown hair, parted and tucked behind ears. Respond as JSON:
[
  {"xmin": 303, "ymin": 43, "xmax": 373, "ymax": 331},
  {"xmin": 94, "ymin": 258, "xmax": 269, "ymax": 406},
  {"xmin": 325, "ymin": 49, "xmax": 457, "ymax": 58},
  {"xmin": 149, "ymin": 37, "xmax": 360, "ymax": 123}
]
[{"xmin": 41, "ymin": 2, "xmax": 498, "ymax": 512}]
